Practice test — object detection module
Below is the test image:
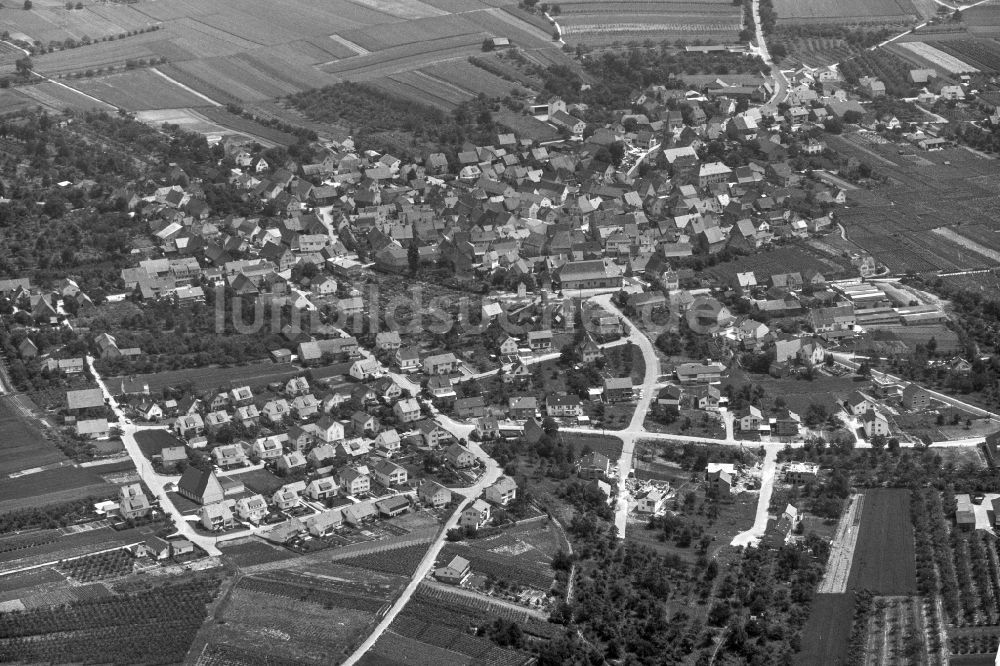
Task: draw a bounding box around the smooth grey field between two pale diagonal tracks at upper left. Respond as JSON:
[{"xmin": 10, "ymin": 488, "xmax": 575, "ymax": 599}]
[{"xmin": 67, "ymin": 69, "xmax": 211, "ymax": 111}]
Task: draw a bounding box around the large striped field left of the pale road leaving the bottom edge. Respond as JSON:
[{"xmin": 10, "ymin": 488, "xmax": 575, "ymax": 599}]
[{"xmin": 204, "ymin": 559, "xmax": 407, "ymax": 664}]
